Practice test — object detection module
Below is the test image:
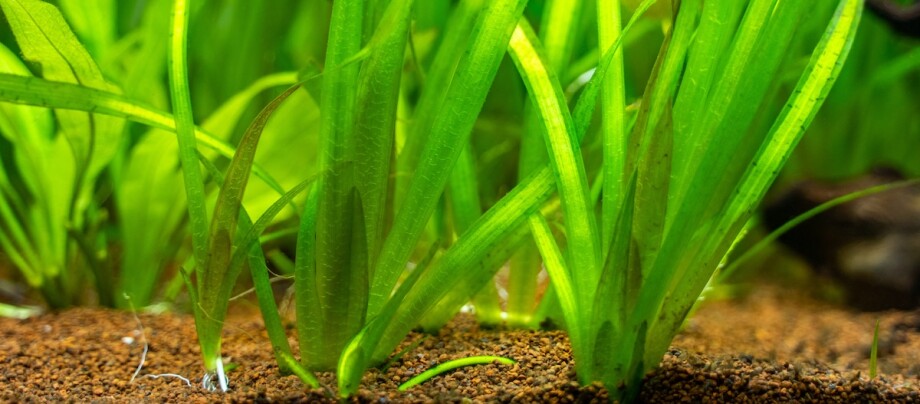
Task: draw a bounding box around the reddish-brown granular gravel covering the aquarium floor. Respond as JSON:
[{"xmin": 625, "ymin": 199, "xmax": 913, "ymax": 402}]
[{"xmin": 0, "ymin": 287, "xmax": 920, "ymax": 403}]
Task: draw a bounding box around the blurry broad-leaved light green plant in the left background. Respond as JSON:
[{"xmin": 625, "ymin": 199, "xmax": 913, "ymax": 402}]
[{"xmin": 0, "ymin": 0, "xmax": 303, "ymax": 308}]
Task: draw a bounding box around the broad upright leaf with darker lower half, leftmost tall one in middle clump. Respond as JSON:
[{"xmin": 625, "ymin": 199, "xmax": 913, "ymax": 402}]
[{"xmin": 308, "ymin": 0, "xmax": 368, "ymax": 370}]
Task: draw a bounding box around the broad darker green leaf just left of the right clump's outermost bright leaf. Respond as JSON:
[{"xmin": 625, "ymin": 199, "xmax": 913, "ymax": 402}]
[{"xmin": 643, "ymin": 3, "xmax": 804, "ymax": 322}]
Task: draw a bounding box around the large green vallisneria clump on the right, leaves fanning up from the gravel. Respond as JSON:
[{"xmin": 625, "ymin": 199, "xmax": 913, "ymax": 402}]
[{"xmin": 524, "ymin": 0, "xmax": 862, "ymax": 398}]
